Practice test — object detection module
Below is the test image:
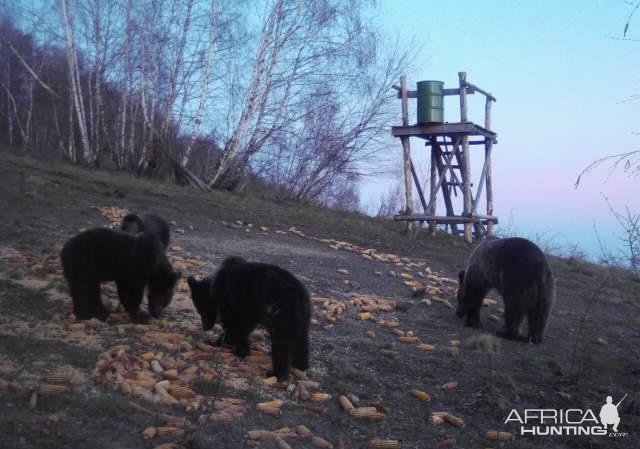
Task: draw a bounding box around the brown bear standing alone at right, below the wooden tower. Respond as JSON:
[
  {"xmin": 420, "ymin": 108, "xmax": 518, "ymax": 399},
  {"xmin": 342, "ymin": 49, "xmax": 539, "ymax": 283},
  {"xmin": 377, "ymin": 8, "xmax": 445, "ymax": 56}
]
[{"xmin": 456, "ymin": 237, "xmax": 555, "ymax": 344}]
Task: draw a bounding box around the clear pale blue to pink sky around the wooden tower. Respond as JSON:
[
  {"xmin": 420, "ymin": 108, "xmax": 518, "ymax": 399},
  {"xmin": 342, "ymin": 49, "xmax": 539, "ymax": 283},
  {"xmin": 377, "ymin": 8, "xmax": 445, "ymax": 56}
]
[{"xmin": 361, "ymin": 0, "xmax": 640, "ymax": 259}]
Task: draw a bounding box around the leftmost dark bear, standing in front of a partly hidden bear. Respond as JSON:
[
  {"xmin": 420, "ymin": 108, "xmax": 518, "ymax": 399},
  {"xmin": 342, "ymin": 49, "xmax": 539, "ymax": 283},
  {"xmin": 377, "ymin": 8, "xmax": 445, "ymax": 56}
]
[{"xmin": 60, "ymin": 228, "xmax": 180, "ymax": 323}]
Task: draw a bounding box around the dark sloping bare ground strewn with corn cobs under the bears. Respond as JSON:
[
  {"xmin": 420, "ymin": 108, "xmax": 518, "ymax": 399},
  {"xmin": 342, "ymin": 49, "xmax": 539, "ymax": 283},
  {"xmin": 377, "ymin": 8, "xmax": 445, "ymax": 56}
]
[{"xmin": 0, "ymin": 150, "xmax": 640, "ymax": 449}]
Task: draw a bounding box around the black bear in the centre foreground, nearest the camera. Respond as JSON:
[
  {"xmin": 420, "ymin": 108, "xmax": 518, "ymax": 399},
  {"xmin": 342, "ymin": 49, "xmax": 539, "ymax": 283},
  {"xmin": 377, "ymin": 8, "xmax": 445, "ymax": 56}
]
[{"xmin": 187, "ymin": 257, "xmax": 311, "ymax": 381}]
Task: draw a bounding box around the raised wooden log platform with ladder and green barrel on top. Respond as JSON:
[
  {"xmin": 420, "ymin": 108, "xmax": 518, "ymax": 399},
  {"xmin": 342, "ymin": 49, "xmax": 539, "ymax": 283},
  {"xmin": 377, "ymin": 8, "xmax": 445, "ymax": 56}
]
[{"xmin": 391, "ymin": 72, "xmax": 498, "ymax": 242}]
